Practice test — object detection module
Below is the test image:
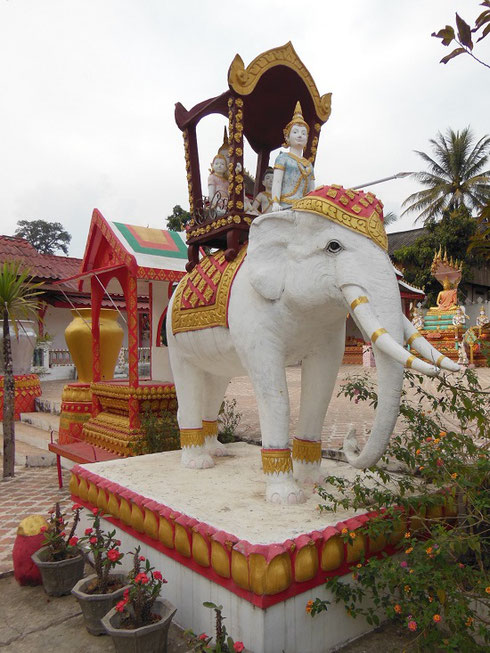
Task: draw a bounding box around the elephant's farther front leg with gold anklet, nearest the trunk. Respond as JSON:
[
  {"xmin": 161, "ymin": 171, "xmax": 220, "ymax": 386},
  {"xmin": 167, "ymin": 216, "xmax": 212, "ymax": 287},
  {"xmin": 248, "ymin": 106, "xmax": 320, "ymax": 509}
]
[{"xmin": 293, "ymin": 346, "xmax": 344, "ymax": 486}]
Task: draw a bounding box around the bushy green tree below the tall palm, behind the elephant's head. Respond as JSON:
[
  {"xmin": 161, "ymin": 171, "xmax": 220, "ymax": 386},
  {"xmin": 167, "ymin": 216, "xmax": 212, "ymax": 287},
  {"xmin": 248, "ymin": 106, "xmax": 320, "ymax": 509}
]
[{"xmin": 393, "ymin": 207, "xmax": 482, "ymax": 306}]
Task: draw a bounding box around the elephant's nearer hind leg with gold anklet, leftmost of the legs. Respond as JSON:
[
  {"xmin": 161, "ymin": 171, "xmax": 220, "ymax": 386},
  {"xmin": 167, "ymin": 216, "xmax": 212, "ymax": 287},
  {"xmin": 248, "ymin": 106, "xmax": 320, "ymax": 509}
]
[{"xmin": 171, "ymin": 355, "xmax": 214, "ymax": 469}]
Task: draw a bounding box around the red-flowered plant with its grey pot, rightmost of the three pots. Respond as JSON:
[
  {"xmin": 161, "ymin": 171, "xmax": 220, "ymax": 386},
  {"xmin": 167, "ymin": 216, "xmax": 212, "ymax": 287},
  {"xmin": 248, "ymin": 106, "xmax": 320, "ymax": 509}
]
[{"xmin": 102, "ymin": 546, "xmax": 177, "ymax": 653}]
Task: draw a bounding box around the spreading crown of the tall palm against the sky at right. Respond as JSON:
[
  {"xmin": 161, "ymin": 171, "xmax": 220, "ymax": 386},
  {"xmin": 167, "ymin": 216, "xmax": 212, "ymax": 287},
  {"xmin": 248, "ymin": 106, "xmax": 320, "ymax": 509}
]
[{"xmin": 402, "ymin": 127, "xmax": 490, "ymax": 222}]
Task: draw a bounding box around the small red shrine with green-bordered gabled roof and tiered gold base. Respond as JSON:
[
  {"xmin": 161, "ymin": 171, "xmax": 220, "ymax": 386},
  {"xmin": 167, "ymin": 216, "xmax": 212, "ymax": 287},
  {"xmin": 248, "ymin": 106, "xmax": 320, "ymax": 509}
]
[{"xmin": 57, "ymin": 209, "xmax": 187, "ymax": 456}]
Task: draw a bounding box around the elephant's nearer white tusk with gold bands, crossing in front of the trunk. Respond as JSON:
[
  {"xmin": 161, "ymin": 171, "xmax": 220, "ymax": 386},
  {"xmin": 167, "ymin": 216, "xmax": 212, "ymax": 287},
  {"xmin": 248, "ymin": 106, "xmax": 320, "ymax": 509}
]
[{"xmin": 341, "ymin": 284, "xmax": 440, "ymax": 376}]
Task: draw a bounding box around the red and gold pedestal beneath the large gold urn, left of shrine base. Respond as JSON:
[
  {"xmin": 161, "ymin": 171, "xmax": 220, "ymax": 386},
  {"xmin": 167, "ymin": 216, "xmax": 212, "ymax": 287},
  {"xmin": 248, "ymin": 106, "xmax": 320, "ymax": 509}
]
[{"xmin": 59, "ymin": 383, "xmax": 92, "ymax": 444}]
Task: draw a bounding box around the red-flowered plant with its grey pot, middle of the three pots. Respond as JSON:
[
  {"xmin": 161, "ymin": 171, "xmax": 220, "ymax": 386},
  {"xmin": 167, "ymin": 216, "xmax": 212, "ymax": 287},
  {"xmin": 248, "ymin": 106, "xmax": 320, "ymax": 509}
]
[{"xmin": 71, "ymin": 508, "xmax": 129, "ymax": 635}]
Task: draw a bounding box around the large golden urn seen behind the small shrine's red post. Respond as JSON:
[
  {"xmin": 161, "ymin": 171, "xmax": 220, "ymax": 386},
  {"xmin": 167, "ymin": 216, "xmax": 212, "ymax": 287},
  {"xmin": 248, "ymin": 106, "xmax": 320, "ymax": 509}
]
[{"xmin": 65, "ymin": 308, "xmax": 124, "ymax": 383}]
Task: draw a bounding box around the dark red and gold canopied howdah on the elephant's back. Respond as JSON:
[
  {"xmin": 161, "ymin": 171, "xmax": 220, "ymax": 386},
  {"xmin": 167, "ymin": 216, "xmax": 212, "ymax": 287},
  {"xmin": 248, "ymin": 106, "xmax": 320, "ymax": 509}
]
[{"xmin": 175, "ymin": 42, "xmax": 331, "ymax": 271}]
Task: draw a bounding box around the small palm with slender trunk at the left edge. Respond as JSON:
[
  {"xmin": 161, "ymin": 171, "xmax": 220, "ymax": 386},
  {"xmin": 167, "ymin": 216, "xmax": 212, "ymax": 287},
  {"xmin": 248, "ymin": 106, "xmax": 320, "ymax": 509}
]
[{"xmin": 0, "ymin": 262, "xmax": 41, "ymax": 478}]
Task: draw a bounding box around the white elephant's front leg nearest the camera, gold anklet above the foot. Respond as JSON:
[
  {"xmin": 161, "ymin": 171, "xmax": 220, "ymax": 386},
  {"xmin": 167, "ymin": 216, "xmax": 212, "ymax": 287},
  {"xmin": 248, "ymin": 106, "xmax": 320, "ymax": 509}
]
[{"xmin": 248, "ymin": 356, "xmax": 306, "ymax": 504}]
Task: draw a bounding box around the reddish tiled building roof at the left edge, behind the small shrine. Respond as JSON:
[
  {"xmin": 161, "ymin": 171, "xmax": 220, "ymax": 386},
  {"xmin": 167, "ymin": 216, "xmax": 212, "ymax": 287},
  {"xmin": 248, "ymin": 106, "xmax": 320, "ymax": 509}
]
[{"xmin": 0, "ymin": 236, "xmax": 82, "ymax": 279}]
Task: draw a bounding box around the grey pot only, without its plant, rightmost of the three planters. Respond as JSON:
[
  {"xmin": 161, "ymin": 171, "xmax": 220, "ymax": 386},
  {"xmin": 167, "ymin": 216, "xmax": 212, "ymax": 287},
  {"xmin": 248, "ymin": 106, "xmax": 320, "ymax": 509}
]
[{"xmin": 102, "ymin": 599, "xmax": 177, "ymax": 653}]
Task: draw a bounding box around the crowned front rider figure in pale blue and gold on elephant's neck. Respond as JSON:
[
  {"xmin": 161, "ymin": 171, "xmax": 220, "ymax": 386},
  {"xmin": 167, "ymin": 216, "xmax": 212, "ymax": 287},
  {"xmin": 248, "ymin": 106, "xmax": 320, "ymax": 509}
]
[{"xmin": 272, "ymin": 102, "xmax": 315, "ymax": 211}]
